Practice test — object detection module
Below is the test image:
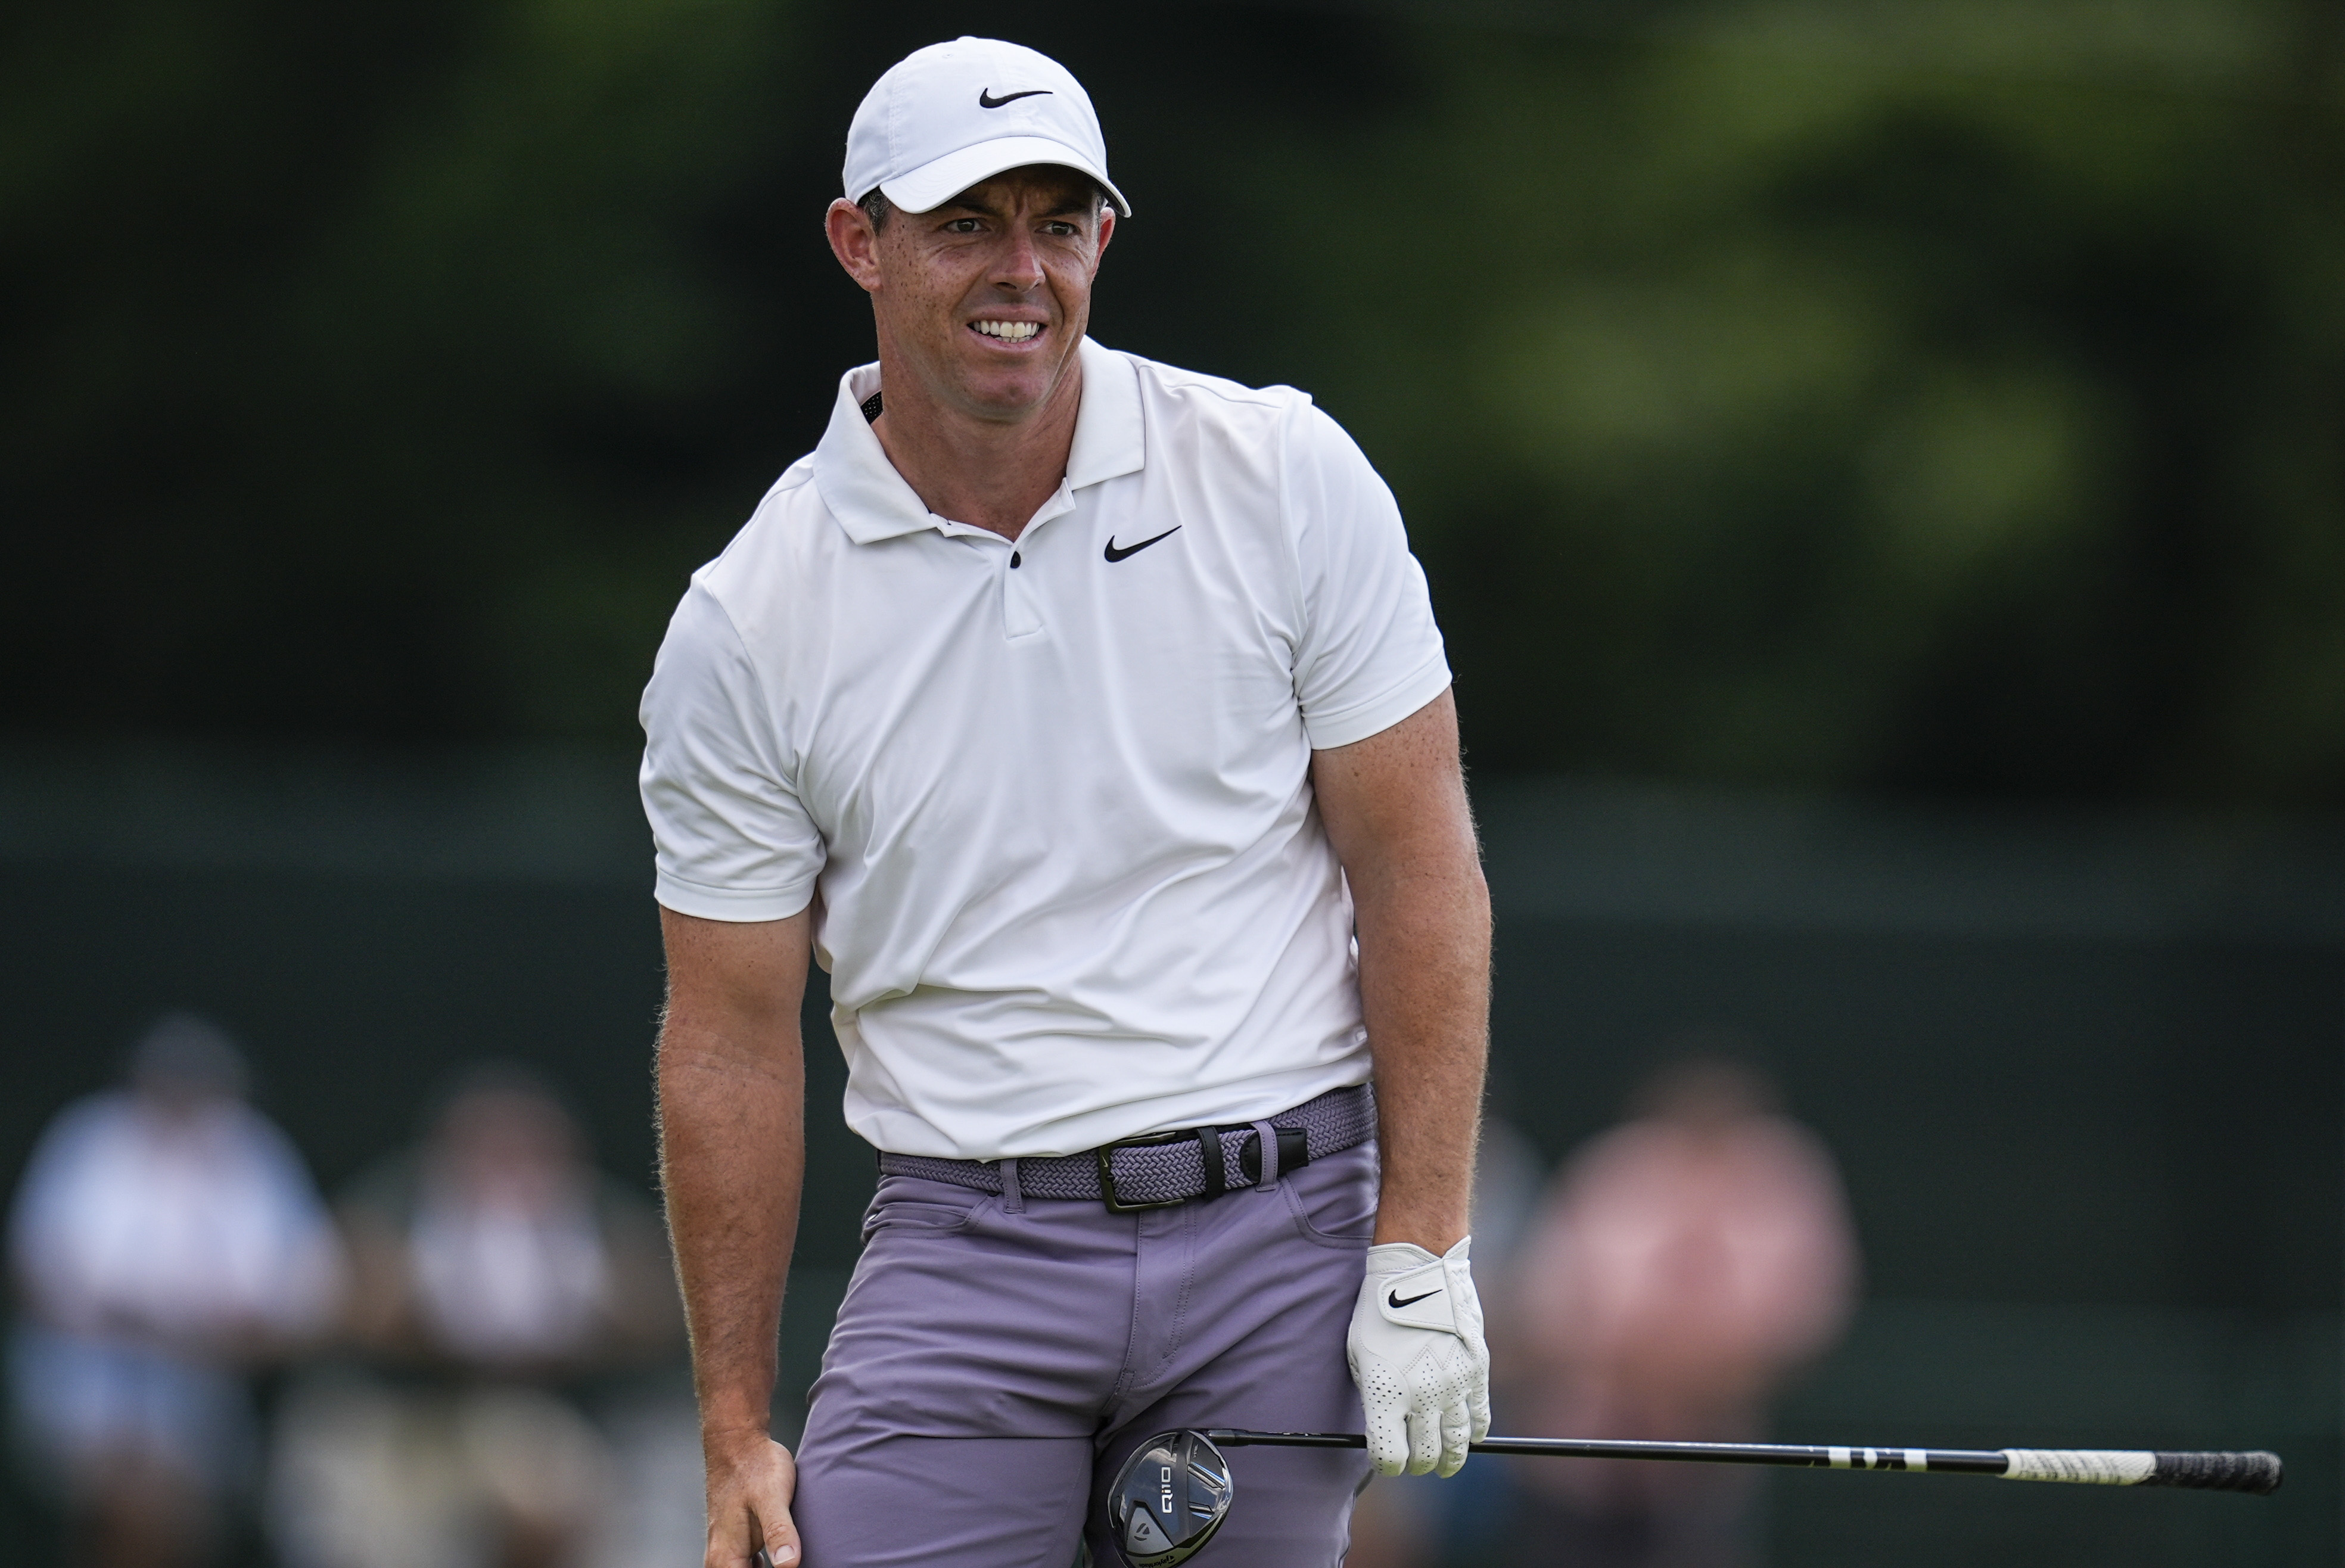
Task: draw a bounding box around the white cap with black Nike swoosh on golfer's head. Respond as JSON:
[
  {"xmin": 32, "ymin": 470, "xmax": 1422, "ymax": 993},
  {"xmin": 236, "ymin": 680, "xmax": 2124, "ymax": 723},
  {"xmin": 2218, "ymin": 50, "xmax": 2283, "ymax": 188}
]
[{"xmin": 847, "ymin": 38, "xmax": 1133, "ymax": 218}]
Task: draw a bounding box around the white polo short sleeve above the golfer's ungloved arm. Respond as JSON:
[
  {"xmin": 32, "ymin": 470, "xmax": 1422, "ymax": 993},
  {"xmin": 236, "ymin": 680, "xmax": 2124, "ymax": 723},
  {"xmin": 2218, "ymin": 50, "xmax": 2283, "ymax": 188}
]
[{"xmin": 640, "ymin": 579, "xmax": 823, "ymax": 921}]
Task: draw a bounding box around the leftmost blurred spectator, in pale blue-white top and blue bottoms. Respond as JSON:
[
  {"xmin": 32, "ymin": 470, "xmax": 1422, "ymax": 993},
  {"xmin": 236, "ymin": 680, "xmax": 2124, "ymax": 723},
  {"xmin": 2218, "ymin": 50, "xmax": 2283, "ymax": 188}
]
[{"xmin": 10, "ymin": 1015, "xmax": 343, "ymax": 1568}]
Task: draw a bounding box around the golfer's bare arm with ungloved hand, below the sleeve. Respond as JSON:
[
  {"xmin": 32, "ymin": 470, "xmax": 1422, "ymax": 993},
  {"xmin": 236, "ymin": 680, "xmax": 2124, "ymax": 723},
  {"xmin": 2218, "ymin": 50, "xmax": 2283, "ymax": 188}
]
[{"xmin": 659, "ymin": 909, "xmax": 814, "ymax": 1568}]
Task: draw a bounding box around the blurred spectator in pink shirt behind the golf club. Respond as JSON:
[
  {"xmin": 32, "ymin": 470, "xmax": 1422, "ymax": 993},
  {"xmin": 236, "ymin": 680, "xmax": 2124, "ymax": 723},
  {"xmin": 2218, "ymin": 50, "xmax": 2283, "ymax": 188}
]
[{"xmin": 1513, "ymin": 1059, "xmax": 1857, "ymax": 1568}]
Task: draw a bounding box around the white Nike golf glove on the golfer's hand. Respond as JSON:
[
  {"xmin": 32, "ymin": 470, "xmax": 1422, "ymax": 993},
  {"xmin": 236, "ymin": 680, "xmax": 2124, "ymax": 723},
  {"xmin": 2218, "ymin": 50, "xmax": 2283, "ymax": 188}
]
[{"xmin": 1346, "ymin": 1235, "xmax": 1489, "ymax": 1477}]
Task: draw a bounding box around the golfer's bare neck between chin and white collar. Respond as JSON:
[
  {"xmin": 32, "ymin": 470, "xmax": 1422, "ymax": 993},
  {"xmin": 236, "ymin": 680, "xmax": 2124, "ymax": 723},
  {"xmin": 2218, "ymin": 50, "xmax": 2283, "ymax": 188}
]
[{"xmin": 872, "ymin": 349, "xmax": 1083, "ymax": 539}]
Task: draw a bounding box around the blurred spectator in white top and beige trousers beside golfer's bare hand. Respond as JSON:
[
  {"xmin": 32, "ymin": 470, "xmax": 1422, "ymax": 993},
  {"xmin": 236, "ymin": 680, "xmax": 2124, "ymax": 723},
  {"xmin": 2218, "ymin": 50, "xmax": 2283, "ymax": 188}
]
[{"xmin": 270, "ymin": 1066, "xmax": 696, "ymax": 1568}]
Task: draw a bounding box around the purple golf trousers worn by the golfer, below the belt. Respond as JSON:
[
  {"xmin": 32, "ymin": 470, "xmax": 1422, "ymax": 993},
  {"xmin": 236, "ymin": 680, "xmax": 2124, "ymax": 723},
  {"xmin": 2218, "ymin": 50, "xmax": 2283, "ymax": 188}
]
[{"xmin": 792, "ymin": 1144, "xmax": 1376, "ymax": 1568}]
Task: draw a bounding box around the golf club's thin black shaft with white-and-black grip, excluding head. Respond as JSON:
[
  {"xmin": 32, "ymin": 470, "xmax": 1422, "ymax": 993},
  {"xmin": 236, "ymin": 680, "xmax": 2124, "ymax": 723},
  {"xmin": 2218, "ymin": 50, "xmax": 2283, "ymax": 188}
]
[{"xmin": 1205, "ymin": 1427, "xmax": 2282, "ymax": 1498}]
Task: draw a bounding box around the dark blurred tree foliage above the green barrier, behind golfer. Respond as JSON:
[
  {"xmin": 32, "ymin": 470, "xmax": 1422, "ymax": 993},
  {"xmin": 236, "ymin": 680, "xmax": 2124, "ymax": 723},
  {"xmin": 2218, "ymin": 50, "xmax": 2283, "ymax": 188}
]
[{"xmin": 0, "ymin": 0, "xmax": 2345, "ymax": 804}]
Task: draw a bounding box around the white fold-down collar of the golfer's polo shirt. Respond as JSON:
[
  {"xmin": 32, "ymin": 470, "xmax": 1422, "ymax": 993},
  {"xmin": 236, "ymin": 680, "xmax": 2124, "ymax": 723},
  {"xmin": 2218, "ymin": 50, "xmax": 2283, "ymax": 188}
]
[{"xmin": 814, "ymin": 338, "xmax": 1147, "ymax": 544}]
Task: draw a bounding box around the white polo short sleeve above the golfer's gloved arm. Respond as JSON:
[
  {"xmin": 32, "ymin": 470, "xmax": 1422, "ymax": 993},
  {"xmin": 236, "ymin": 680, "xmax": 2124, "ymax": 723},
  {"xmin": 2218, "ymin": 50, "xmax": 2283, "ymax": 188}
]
[{"xmin": 1285, "ymin": 403, "xmax": 1449, "ymax": 750}]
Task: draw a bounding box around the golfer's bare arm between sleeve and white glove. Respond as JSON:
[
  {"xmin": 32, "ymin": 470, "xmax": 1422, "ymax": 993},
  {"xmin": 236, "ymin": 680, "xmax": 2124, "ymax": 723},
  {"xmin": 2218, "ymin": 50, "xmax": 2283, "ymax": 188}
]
[{"xmin": 1311, "ymin": 692, "xmax": 1489, "ymax": 1254}]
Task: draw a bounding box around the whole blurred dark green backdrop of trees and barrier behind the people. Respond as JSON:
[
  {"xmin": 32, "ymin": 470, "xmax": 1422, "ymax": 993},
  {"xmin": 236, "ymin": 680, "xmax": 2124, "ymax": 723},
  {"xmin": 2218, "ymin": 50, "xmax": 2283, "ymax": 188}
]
[{"xmin": 0, "ymin": 0, "xmax": 2345, "ymax": 1566}]
